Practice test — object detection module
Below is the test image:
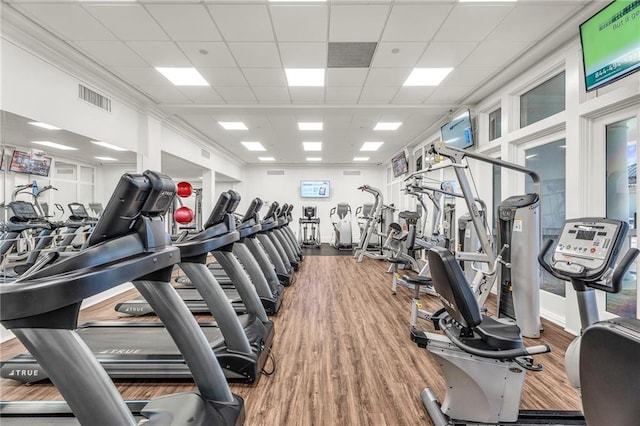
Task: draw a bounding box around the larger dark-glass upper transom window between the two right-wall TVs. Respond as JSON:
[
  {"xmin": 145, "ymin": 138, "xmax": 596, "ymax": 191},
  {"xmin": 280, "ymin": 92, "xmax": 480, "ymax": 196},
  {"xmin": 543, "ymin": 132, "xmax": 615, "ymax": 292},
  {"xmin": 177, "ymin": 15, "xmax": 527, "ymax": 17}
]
[{"xmin": 520, "ymin": 71, "xmax": 565, "ymax": 128}]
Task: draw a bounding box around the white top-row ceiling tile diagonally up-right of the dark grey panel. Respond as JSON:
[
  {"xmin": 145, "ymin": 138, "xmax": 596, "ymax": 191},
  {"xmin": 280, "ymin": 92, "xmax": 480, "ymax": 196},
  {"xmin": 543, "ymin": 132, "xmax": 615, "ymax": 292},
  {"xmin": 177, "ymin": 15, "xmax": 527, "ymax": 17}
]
[{"xmin": 382, "ymin": 4, "xmax": 453, "ymax": 41}]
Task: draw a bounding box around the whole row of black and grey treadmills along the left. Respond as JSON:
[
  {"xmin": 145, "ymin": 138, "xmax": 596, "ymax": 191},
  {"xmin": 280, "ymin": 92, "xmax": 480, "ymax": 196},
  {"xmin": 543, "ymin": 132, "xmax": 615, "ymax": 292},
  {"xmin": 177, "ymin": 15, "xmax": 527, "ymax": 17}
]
[{"xmin": 0, "ymin": 171, "xmax": 302, "ymax": 426}]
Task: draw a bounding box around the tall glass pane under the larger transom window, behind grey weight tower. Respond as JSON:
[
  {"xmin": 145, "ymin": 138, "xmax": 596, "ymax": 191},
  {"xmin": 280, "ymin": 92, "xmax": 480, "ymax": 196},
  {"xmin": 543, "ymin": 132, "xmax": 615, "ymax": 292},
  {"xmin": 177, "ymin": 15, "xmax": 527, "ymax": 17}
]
[{"xmin": 525, "ymin": 139, "xmax": 566, "ymax": 297}]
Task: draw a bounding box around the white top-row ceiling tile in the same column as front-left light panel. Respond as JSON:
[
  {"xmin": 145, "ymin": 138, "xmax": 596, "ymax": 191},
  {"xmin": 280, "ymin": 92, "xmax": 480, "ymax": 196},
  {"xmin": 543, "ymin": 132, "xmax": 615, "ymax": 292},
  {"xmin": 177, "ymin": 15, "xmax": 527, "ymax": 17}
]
[{"xmin": 84, "ymin": 4, "xmax": 169, "ymax": 41}]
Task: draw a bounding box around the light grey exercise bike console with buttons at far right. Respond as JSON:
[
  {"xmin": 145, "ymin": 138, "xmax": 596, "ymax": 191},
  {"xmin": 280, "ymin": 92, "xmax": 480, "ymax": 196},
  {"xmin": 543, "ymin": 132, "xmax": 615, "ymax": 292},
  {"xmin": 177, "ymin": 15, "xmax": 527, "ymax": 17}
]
[{"xmin": 551, "ymin": 218, "xmax": 628, "ymax": 280}]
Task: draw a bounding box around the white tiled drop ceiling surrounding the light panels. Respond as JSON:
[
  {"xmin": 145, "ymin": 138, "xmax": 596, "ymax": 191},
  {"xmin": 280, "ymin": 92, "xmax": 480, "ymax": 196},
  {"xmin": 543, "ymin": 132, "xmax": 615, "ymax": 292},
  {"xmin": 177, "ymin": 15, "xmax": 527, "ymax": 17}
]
[{"xmin": 3, "ymin": 0, "xmax": 597, "ymax": 165}]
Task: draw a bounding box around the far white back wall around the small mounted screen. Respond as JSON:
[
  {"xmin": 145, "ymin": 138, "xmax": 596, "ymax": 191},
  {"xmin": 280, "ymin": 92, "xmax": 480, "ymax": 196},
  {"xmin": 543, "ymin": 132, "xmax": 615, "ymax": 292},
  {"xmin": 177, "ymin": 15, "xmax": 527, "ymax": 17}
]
[{"xmin": 241, "ymin": 166, "xmax": 384, "ymax": 243}]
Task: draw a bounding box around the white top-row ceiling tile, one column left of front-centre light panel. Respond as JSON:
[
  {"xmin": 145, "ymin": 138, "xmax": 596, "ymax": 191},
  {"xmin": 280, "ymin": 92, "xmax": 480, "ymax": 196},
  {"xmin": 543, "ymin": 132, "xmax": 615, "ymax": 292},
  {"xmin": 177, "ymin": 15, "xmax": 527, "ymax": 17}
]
[{"xmin": 208, "ymin": 4, "xmax": 273, "ymax": 41}]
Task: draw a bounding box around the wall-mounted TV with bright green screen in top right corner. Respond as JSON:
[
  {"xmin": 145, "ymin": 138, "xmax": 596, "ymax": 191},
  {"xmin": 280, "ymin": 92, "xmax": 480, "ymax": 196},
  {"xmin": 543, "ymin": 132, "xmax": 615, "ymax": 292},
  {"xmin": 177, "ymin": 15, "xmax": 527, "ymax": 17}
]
[{"xmin": 580, "ymin": 0, "xmax": 640, "ymax": 91}]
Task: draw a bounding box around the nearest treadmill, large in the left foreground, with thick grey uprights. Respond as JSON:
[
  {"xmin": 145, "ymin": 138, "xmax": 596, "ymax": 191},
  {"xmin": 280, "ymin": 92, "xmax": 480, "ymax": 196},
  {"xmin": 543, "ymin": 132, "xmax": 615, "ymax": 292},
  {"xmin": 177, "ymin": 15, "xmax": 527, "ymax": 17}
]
[{"xmin": 0, "ymin": 171, "xmax": 244, "ymax": 426}]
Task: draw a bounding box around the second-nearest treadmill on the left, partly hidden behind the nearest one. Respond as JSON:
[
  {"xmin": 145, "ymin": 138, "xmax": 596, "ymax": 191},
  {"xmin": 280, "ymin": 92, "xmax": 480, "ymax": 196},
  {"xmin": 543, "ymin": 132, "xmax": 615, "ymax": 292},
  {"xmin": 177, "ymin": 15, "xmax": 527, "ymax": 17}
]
[{"xmin": 0, "ymin": 193, "xmax": 273, "ymax": 383}]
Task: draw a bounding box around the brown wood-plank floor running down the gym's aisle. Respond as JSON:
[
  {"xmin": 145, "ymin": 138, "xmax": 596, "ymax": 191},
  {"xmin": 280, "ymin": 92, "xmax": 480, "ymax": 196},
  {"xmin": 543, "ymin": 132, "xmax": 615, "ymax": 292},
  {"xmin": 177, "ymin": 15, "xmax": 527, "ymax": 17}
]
[{"xmin": 0, "ymin": 256, "xmax": 580, "ymax": 425}]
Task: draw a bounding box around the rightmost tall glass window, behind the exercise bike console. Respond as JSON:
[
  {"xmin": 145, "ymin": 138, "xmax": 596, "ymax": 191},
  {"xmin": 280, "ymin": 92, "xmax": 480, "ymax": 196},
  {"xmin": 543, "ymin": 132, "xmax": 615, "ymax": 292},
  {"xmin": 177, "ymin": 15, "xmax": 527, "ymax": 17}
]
[{"xmin": 606, "ymin": 118, "xmax": 638, "ymax": 318}]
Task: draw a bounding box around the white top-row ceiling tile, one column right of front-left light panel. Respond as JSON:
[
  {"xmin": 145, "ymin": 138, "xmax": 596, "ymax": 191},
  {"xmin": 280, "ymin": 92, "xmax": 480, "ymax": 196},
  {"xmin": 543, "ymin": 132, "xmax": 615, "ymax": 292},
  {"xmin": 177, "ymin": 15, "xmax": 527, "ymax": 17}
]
[{"xmin": 146, "ymin": 4, "xmax": 222, "ymax": 41}]
